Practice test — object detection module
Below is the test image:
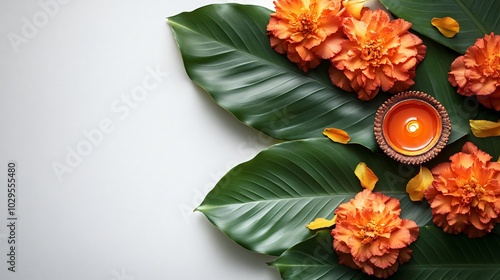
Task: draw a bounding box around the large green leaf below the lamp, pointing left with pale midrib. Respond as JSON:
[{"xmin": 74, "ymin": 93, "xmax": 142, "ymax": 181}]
[{"xmin": 197, "ymin": 139, "xmax": 431, "ymax": 255}]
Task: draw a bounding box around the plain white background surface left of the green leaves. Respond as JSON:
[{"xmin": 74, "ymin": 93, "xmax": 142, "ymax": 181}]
[{"xmin": 0, "ymin": 0, "xmax": 279, "ymax": 280}]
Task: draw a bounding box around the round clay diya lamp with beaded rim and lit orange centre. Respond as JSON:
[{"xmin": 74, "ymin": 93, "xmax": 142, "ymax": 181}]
[{"xmin": 374, "ymin": 91, "xmax": 451, "ymax": 164}]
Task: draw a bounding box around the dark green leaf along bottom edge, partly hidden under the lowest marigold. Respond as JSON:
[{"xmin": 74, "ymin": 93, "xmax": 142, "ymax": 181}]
[{"xmin": 271, "ymin": 228, "xmax": 500, "ymax": 280}]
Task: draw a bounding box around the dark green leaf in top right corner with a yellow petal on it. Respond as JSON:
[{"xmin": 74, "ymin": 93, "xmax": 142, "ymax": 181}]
[{"xmin": 380, "ymin": 0, "xmax": 500, "ymax": 54}]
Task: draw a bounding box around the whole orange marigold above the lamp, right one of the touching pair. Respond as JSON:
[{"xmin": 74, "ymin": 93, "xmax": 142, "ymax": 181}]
[{"xmin": 330, "ymin": 10, "xmax": 426, "ymax": 100}]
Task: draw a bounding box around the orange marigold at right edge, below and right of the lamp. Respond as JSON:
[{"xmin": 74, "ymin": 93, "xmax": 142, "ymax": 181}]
[{"xmin": 424, "ymin": 142, "xmax": 500, "ymax": 238}]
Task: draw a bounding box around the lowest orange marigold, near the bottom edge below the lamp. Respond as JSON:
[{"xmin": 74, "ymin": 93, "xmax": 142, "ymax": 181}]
[{"xmin": 332, "ymin": 189, "xmax": 419, "ymax": 278}]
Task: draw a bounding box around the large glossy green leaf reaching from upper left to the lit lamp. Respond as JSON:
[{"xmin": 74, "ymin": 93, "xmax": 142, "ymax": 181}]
[{"xmin": 168, "ymin": 4, "xmax": 387, "ymax": 149}]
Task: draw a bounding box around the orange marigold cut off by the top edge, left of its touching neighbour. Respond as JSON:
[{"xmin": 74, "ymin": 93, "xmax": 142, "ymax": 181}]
[{"xmin": 267, "ymin": 0, "xmax": 345, "ymax": 72}]
